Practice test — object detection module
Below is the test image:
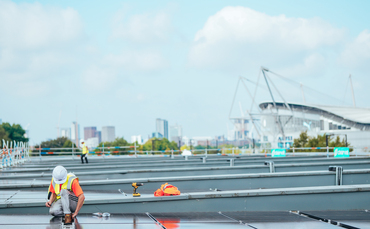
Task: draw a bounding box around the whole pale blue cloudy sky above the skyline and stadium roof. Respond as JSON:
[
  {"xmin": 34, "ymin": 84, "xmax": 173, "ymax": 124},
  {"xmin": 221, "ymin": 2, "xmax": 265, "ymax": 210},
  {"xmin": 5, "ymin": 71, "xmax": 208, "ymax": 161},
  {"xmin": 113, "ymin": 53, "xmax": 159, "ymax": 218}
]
[{"xmin": 0, "ymin": 0, "xmax": 370, "ymax": 143}]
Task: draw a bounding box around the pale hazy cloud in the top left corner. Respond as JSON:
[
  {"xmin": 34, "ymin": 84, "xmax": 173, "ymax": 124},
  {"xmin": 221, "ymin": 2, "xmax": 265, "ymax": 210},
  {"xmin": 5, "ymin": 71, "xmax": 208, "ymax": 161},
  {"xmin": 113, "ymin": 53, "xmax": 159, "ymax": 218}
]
[{"xmin": 0, "ymin": 1, "xmax": 82, "ymax": 49}]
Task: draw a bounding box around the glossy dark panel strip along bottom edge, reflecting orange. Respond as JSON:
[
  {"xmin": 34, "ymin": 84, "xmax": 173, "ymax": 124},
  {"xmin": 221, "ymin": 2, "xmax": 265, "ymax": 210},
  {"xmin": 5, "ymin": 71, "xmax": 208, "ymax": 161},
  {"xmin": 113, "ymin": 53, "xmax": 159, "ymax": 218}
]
[{"xmin": 0, "ymin": 211, "xmax": 370, "ymax": 229}]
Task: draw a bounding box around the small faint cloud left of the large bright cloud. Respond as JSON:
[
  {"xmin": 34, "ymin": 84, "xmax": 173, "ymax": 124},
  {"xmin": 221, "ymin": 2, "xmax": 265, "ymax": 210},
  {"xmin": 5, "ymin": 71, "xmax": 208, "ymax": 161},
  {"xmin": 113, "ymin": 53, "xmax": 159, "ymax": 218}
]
[{"xmin": 112, "ymin": 11, "xmax": 171, "ymax": 43}]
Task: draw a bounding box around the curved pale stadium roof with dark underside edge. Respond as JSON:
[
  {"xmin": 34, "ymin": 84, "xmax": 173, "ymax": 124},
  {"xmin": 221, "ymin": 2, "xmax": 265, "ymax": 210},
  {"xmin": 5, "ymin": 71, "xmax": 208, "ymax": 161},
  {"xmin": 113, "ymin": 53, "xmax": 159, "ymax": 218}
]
[{"xmin": 259, "ymin": 102, "xmax": 370, "ymax": 131}]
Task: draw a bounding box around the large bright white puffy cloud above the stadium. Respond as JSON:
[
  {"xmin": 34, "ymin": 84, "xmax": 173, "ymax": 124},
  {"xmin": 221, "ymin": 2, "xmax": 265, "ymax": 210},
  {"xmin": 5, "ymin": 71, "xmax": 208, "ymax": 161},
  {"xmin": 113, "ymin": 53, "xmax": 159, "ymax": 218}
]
[{"xmin": 189, "ymin": 7, "xmax": 345, "ymax": 69}]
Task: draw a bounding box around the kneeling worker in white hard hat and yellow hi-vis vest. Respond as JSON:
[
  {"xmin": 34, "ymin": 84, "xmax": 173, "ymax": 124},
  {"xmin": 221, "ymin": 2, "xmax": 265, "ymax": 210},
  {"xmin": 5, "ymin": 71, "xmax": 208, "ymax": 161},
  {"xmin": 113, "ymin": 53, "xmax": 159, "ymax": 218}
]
[{"xmin": 45, "ymin": 165, "xmax": 85, "ymax": 224}]
